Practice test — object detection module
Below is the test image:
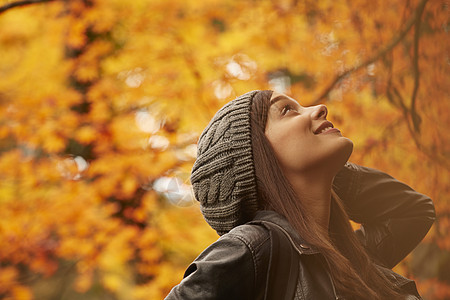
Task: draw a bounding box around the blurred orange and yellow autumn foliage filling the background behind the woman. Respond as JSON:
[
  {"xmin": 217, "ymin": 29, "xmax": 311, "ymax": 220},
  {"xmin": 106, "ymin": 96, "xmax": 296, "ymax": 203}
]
[{"xmin": 0, "ymin": 0, "xmax": 450, "ymax": 299}]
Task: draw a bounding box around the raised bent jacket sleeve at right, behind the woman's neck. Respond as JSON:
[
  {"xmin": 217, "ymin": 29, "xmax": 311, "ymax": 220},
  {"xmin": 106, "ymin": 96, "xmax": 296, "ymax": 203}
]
[{"xmin": 334, "ymin": 163, "xmax": 435, "ymax": 268}]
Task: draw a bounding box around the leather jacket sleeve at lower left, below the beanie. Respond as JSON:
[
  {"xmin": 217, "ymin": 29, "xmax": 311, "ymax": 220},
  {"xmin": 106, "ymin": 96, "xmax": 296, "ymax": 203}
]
[{"xmin": 166, "ymin": 230, "xmax": 264, "ymax": 300}]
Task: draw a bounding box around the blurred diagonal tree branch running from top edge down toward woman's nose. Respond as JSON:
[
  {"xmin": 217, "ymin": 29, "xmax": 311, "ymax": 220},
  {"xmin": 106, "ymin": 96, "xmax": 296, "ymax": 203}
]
[{"xmin": 312, "ymin": 0, "xmax": 428, "ymax": 105}]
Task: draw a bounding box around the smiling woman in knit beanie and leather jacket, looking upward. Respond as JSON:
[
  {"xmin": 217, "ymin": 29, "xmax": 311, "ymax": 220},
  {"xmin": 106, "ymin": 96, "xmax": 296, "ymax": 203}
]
[{"xmin": 166, "ymin": 91, "xmax": 435, "ymax": 299}]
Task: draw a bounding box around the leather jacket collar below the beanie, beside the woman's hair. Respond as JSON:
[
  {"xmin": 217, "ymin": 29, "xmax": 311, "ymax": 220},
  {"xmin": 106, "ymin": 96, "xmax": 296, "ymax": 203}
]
[{"xmin": 249, "ymin": 210, "xmax": 320, "ymax": 254}]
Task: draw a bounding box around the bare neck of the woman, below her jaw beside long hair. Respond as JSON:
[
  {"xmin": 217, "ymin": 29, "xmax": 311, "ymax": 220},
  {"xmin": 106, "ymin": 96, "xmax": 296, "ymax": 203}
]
[{"xmin": 287, "ymin": 169, "xmax": 333, "ymax": 233}]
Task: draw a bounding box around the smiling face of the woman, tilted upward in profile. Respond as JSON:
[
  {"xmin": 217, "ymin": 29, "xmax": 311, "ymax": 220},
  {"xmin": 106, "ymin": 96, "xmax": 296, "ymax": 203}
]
[{"xmin": 265, "ymin": 92, "xmax": 353, "ymax": 173}]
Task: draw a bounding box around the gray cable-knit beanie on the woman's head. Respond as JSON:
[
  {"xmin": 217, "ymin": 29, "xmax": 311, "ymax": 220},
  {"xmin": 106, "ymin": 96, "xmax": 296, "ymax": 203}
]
[{"xmin": 191, "ymin": 91, "xmax": 258, "ymax": 235}]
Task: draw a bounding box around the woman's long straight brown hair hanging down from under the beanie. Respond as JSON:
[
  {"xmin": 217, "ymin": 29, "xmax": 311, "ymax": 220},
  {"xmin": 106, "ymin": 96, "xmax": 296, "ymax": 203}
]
[{"xmin": 251, "ymin": 91, "xmax": 402, "ymax": 299}]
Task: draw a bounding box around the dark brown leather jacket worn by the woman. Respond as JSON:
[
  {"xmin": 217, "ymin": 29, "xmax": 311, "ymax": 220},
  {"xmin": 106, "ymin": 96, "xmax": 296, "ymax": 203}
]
[{"xmin": 166, "ymin": 163, "xmax": 435, "ymax": 300}]
